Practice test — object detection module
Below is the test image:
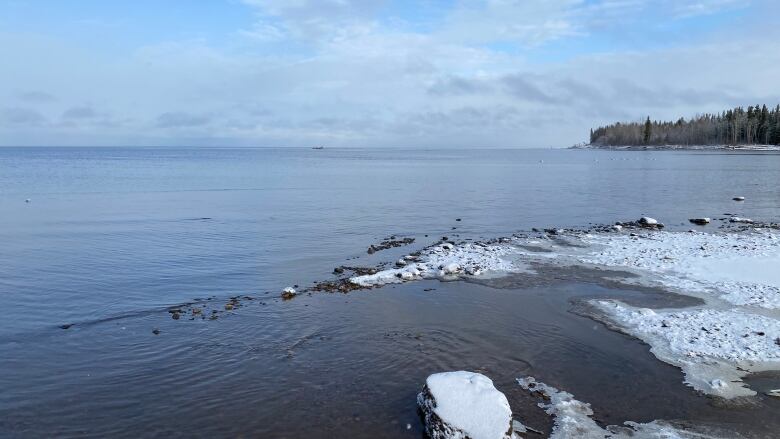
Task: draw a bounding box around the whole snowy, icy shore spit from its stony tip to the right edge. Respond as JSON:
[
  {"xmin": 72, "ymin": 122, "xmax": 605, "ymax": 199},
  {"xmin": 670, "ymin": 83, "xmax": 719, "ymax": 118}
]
[{"xmin": 350, "ymin": 225, "xmax": 780, "ymax": 398}]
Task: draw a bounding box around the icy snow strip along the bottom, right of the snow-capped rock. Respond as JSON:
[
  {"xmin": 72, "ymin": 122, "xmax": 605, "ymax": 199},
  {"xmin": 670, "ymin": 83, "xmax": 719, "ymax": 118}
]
[{"xmin": 517, "ymin": 377, "xmax": 715, "ymax": 439}]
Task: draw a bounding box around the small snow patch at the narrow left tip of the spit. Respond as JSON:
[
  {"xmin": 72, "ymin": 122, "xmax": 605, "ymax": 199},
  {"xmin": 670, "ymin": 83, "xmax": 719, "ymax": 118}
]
[{"xmin": 349, "ymin": 243, "xmax": 517, "ymax": 287}]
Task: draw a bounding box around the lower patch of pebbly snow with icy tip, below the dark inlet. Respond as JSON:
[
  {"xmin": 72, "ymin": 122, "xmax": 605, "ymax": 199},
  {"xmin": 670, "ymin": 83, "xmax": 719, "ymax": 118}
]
[{"xmin": 591, "ymin": 300, "xmax": 780, "ymax": 398}]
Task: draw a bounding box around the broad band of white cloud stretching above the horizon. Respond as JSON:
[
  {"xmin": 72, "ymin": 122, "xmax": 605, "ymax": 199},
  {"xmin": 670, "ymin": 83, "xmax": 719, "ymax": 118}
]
[{"xmin": 0, "ymin": 0, "xmax": 780, "ymax": 146}]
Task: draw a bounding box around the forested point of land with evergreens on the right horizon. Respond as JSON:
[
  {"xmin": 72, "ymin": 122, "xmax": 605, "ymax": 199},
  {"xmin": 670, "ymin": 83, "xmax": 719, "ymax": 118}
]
[{"xmin": 590, "ymin": 105, "xmax": 780, "ymax": 146}]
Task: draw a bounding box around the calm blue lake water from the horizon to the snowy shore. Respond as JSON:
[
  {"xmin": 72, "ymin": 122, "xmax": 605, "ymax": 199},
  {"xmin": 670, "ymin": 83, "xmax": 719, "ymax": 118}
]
[{"xmin": 0, "ymin": 148, "xmax": 780, "ymax": 438}]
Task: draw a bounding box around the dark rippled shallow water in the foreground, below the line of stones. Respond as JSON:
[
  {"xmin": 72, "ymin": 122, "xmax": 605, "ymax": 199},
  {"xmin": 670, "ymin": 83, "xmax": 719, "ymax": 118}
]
[{"xmin": 6, "ymin": 281, "xmax": 780, "ymax": 438}]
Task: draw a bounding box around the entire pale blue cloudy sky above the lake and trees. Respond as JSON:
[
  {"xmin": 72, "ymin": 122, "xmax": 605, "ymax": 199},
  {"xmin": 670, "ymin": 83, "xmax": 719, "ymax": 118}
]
[{"xmin": 0, "ymin": 0, "xmax": 780, "ymax": 148}]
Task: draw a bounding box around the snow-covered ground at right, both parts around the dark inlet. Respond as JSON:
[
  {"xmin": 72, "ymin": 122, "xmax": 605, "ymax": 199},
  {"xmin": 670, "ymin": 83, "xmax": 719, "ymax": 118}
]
[{"xmin": 581, "ymin": 229, "xmax": 780, "ymax": 398}]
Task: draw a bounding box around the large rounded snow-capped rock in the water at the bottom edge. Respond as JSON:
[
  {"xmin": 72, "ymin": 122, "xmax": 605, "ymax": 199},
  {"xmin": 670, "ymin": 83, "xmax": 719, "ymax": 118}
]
[{"xmin": 417, "ymin": 371, "xmax": 513, "ymax": 439}]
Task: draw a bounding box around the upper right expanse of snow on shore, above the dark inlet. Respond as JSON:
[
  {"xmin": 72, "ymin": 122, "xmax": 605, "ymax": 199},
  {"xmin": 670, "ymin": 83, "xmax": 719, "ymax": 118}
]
[{"xmin": 580, "ymin": 230, "xmax": 780, "ymax": 309}]
